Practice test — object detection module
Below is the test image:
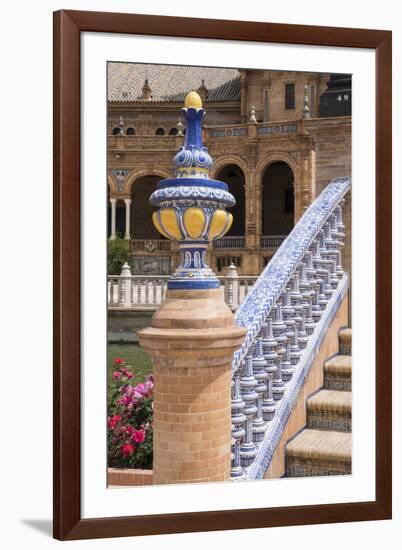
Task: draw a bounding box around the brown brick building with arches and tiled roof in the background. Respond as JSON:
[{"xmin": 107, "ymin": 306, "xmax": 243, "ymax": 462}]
[{"xmin": 107, "ymin": 63, "xmax": 351, "ymax": 275}]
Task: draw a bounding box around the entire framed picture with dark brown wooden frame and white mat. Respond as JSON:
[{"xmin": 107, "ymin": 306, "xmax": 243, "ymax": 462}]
[{"xmin": 54, "ymin": 10, "xmax": 392, "ymax": 540}]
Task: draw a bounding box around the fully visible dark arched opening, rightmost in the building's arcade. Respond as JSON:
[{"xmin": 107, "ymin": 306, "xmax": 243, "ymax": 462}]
[{"xmin": 262, "ymin": 161, "xmax": 294, "ymax": 235}]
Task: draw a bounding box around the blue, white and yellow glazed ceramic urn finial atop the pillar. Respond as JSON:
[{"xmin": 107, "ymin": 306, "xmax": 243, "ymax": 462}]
[{"xmin": 150, "ymin": 92, "xmax": 235, "ymax": 289}]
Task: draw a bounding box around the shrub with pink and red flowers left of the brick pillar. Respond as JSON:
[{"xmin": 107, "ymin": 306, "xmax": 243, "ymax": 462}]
[{"xmin": 108, "ymin": 357, "xmax": 154, "ymax": 469}]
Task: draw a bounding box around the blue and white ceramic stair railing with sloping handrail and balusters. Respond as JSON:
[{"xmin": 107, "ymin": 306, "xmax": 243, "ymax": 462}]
[{"xmin": 232, "ymin": 178, "xmax": 350, "ymax": 479}]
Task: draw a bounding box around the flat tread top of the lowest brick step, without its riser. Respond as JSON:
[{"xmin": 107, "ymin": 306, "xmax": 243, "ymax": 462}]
[{"xmin": 286, "ymin": 429, "xmax": 352, "ymax": 462}]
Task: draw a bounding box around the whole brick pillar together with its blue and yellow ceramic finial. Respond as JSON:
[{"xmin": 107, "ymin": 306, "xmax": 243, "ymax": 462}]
[{"xmin": 139, "ymin": 92, "xmax": 245, "ymax": 484}]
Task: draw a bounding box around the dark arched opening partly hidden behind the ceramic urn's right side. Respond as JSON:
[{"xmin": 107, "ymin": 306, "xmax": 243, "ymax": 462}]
[{"xmin": 216, "ymin": 164, "xmax": 246, "ymax": 237}]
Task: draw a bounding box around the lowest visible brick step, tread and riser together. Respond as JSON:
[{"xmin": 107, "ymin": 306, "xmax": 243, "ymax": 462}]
[{"xmin": 285, "ymin": 429, "xmax": 352, "ymax": 477}]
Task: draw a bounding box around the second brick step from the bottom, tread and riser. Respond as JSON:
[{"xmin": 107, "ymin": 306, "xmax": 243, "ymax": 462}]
[{"xmin": 307, "ymin": 390, "xmax": 352, "ymax": 432}]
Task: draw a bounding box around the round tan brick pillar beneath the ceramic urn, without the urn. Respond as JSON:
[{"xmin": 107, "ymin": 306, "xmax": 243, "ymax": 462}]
[{"xmin": 139, "ymin": 289, "xmax": 245, "ymax": 484}]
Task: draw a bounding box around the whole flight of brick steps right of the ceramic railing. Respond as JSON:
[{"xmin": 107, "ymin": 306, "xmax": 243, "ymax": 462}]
[{"xmin": 285, "ymin": 328, "xmax": 352, "ymax": 477}]
